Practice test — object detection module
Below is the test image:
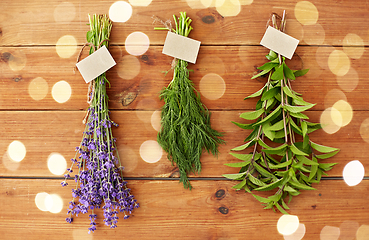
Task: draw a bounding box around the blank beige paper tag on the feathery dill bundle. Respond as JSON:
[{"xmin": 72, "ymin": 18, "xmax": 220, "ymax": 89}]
[{"xmin": 163, "ymin": 32, "xmax": 201, "ymax": 63}]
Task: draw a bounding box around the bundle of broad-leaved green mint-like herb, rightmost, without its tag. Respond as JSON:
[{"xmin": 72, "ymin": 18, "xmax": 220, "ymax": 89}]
[{"xmin": 223, "ymin": 11, "xmax": 339, "ymax": 214}]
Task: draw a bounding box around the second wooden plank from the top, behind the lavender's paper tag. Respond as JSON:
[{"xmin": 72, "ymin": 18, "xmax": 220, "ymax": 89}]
[{"xmin": 0, "ymin": 46, "xmax": 369, "ymax": 110}]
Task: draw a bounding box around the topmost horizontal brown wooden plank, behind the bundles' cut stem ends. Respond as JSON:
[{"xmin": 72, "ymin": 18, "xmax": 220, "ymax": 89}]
[{"xmin": 0, "ymin": 0, "xmax": 369, "ymax": 45}]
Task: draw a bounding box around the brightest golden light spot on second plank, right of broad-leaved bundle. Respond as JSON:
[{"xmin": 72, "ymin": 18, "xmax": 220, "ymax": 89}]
[{"xmin": 328, "ymin": 50, "xmax": 350, "ymax": 76}]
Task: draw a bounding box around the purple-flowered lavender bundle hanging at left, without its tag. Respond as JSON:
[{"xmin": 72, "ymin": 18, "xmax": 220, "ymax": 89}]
[{"xmin": 62, "ymin": 15, "xmax": 139, "ymax": 232}]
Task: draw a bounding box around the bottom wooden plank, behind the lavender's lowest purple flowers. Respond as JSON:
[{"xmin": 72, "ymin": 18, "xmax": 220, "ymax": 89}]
[{"xmin": 0, "ymin": 179, "xmax": 369, "ymax": 240}]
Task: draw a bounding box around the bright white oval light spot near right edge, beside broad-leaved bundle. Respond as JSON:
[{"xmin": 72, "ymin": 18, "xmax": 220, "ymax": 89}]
[{"xmin": 342, "ymin": 160, "xmax": 365, "ymax": 187}]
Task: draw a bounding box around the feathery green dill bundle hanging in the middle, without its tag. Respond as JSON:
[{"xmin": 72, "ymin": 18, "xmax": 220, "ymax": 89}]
[{"xmin": 155, "ymin": 12, "xmax": 224, "ymax": 189}]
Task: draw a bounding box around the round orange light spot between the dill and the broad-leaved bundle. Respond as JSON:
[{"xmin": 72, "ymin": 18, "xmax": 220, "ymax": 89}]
[{"xmin": 200, "ymin": 73, "xmax": 226, "ymax": 100}]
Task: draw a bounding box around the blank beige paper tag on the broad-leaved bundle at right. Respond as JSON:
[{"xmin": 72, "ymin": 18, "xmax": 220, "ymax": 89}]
[{"xmin": 260, "ymin": 26, "xmax": 299, "ymax": 59}]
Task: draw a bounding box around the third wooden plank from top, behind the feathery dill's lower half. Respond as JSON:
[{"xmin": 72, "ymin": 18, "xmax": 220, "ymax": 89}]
[{"xmin": 0, "ymin": 111, "xmax": 369, "ymax": 177}]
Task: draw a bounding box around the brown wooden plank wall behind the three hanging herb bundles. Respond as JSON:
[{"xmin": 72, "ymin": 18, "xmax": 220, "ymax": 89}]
[{"xmin": 0, "ymin": 0, "xmax": 369, "ymax": 240}]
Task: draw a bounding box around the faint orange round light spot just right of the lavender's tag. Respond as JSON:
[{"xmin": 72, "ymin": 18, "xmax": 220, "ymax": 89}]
[{"xmin": 116, "ymin": 55, "xmax": 141, "ymax": 80}]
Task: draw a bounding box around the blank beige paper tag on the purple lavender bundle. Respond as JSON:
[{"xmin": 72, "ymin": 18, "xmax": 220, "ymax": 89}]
[{"xmin": 76, "ymin": 46, "xmax": 116, "ymax": 83}]
